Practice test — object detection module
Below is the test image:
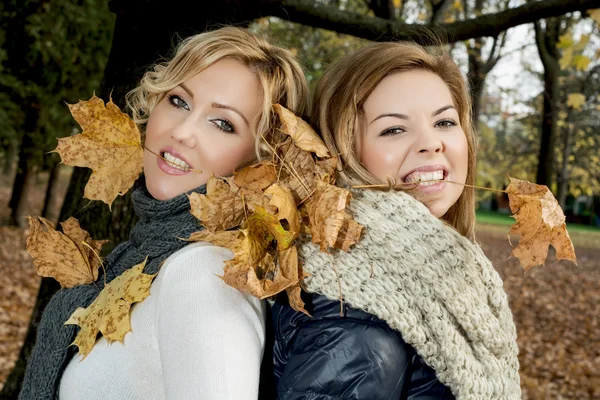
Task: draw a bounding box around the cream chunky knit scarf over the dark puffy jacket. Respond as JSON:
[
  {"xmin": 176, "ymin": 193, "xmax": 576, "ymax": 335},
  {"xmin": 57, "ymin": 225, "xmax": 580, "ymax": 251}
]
[{"xmin": 300, "ymin": 191, "xmax": 521, "ymax": 400}]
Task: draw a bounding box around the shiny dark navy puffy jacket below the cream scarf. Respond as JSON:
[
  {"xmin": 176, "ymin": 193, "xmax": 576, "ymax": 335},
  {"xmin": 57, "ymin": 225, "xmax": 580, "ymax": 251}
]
[{"xmin": 272, "ymin": 293, "xmax": 454, "ymax": 400}]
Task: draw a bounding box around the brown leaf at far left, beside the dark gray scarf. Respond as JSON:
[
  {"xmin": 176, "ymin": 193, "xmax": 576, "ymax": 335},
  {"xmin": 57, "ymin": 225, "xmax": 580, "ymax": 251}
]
[{"xmin": 27, "ymin": 216, "xmax": 107, "ymax": 288}]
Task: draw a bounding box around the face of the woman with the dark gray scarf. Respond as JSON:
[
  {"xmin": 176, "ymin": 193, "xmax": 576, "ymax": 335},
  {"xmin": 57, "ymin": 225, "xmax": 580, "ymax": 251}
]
[{"xmin": 144, "ymin": 58, "xmax": 262, "ymax": 200}]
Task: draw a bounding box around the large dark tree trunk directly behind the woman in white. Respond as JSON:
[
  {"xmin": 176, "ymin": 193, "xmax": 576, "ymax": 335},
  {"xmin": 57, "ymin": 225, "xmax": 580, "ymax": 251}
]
[{"xmin": 0, "ymin": 0, "xmax": 263, "ymax": 400}]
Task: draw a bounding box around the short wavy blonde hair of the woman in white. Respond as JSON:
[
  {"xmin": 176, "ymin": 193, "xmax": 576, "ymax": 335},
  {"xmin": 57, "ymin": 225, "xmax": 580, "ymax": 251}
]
[{"xmin": 126, "ymin": 27, "xmax": 309, "ymax": 157}]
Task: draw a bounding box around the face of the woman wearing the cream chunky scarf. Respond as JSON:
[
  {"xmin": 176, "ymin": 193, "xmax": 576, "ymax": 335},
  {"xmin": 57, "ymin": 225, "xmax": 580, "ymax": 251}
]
[{"xmin": 355, "ymin": 69, "xmax": 468, "ymax": 218}]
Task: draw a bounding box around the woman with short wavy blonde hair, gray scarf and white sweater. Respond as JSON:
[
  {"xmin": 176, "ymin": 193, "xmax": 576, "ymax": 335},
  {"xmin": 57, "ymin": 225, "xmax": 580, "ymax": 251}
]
[{"xmin": 19, "ymin": 27, "xmax": 308, "ymax": 400}]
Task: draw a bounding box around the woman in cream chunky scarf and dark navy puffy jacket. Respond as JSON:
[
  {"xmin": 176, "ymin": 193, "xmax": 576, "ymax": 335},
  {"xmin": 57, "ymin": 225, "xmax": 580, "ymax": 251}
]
[{"xmin": 273, "ymin": 43, "xmax": 521, "ymax": 400}]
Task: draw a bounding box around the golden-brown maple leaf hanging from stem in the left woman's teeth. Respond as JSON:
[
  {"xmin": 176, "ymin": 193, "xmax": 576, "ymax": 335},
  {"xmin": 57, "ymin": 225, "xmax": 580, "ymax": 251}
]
[{"xmin": 54, "ymin": 96, "xmax": 143, "ymax": 208}]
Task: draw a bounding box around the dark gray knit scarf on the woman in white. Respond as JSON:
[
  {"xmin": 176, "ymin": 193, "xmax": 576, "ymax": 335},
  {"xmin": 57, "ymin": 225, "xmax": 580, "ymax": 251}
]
[{"xmin": 19, "ymin": 185, "xmax": 206, "ymax": 400}]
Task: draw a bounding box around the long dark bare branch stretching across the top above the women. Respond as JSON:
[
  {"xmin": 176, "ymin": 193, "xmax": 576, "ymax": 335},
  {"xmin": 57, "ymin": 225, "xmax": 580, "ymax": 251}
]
[{"xmin": 264, "ymin": 0, "xmax": 600, "ymax": 44}]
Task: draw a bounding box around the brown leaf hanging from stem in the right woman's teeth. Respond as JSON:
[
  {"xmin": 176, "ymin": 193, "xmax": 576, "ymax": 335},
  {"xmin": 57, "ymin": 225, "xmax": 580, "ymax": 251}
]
[{"xmin": 506, "ymin": 178, "xmax": 577, "ymax": 271}]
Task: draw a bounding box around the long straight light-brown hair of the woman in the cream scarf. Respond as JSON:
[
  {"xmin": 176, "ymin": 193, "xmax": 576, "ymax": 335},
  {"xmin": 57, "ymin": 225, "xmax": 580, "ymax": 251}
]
[{"xmin": 311, "ymin": 42, "xmax": 477, "ymax": 240}]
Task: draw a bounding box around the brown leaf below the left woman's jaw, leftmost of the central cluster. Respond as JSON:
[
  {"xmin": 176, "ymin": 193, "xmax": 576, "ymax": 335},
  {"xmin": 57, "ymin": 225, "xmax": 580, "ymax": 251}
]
[{"xmin": 188, "ymin": 176, "xmax": 245, "ymax": 232}]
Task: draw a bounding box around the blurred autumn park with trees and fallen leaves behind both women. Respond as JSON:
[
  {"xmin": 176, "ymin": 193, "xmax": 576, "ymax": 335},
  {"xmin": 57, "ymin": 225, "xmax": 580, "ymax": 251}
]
[{"xmin": 0, "ymin": 0, "xmax": 600, "ymax": 399}]
